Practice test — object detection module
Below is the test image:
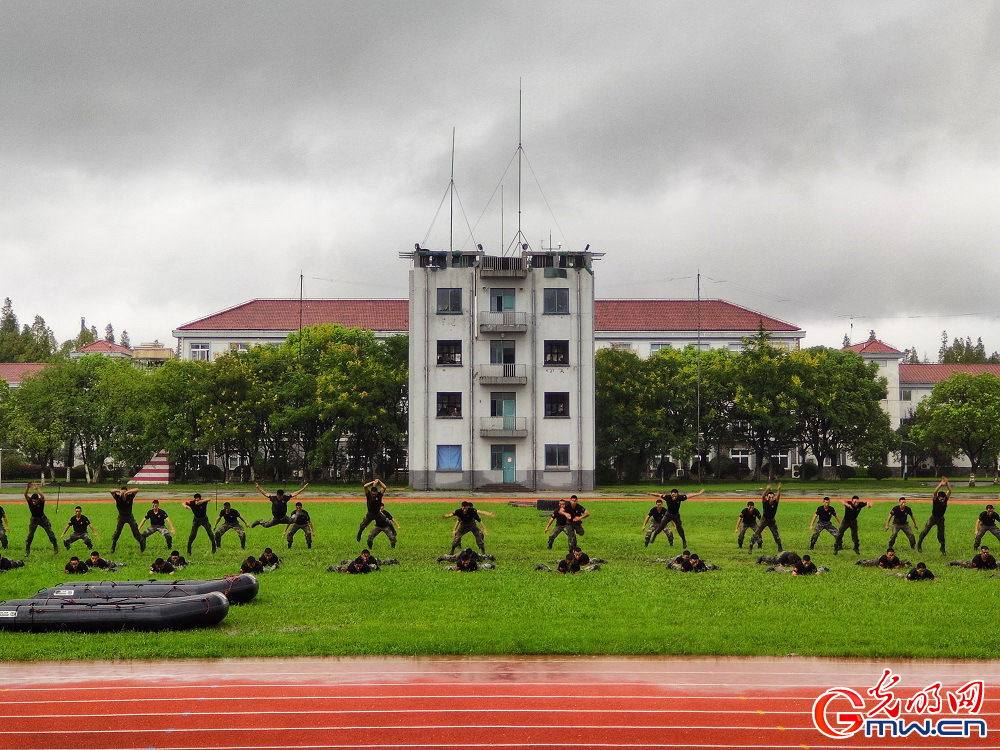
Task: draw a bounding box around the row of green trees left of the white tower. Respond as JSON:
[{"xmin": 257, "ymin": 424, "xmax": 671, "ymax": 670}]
[{"xmin": 0, "ymin": 325, "xmax": 407, "ymax": 481}]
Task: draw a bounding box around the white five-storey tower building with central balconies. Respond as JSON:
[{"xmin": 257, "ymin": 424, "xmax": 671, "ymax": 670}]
[{"xmin": 402, "ymin": 250, "xmax": 599, "ymax": 490}]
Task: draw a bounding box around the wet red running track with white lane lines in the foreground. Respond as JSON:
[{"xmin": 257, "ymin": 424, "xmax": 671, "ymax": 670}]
[{"xmin": 0, "ymin": 657, "xmax": 1000, "ymax": 750}]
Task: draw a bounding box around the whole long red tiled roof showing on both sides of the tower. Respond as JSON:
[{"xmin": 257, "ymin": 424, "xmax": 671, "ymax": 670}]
[{"xmin": 177, "ymin": 299, "xmax": 802, "ymax": 331}]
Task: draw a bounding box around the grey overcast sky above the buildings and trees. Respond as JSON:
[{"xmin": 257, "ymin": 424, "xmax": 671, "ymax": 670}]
[{"xmin": 0, "ymin": 0, "xmax": 1000, "ymax": 361}]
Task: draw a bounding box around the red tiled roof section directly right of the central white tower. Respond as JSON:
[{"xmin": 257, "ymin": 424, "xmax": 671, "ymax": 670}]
[{"xmin": 594, "ymin": 299, "xmax": 802, "ymax": 331}]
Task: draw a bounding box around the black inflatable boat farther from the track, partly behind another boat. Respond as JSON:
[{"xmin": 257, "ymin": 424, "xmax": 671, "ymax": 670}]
[{"xmin": 31, "ymin": 573, "xmax": 260, "ymax": 604}]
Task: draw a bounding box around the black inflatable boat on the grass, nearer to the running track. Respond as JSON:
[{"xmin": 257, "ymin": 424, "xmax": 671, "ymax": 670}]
[{"xmin": 0, "ymin": 591, "xmax": 229, "ymax": 631}]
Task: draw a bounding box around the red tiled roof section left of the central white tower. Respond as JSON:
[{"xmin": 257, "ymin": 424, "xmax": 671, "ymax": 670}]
[{"xmin": 177, "ymin": 299, "xmax": 410, "ymax": 331}]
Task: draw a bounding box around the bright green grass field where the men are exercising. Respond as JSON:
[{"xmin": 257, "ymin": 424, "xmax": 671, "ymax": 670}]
[{"xmin": 0, "ymin": 494, "xmax": 1000, "ymax": 660}]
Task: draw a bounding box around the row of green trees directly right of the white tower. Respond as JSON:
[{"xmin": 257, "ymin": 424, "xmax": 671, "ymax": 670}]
[{"xmin": 596, "ymin": 331, "xmax": 897, "ymax": 482}]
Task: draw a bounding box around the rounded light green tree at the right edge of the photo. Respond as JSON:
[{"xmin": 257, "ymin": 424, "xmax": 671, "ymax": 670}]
[{"xmin": 910, "ymin": 372, "xmax": 1000, "ymax": 474}]
